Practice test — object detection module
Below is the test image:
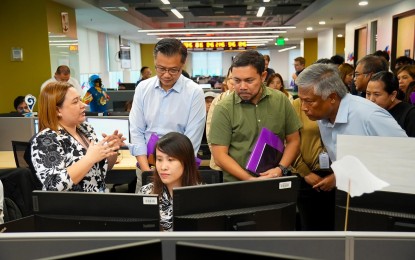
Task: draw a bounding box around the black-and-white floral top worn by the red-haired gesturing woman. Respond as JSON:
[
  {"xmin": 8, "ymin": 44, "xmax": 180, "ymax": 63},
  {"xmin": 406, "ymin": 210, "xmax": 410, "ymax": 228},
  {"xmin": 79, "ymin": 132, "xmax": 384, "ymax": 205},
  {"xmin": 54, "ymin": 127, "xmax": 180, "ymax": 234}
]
[{"xmin": 31, "ymin": 122, "xmax": 108, "ymax": 192}]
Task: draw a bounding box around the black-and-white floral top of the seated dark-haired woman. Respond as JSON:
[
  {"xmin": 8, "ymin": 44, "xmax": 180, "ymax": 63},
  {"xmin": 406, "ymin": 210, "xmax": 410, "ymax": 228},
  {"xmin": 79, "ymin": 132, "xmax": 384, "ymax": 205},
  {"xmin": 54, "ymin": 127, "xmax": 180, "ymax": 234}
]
[{"xmin": 139, "ymin": 183, "xmax": 173, "ymax": 231}]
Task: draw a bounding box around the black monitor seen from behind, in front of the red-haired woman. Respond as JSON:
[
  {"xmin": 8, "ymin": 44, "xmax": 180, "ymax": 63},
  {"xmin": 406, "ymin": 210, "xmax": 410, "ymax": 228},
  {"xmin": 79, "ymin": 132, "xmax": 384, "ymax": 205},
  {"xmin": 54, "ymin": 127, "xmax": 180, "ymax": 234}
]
[{"xmin": 32, "ymin": 190, "xmax": 160, "ymax": 232}]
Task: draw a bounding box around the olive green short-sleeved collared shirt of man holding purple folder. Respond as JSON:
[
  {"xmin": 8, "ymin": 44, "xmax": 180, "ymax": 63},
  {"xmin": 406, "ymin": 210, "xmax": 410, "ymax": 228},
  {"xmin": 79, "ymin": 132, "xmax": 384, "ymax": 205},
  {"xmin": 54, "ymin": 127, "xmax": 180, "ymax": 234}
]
[{"xmin": 209, "ymin": 86, "xmax": 302, "ymax": 181}]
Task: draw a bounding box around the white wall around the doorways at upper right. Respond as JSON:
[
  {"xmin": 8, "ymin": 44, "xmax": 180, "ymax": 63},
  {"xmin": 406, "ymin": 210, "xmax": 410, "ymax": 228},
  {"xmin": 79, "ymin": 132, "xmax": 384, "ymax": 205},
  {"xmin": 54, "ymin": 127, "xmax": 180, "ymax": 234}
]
[{"xmin": 345, "ymin": 0, "xmax": 415, "ymax": 63}]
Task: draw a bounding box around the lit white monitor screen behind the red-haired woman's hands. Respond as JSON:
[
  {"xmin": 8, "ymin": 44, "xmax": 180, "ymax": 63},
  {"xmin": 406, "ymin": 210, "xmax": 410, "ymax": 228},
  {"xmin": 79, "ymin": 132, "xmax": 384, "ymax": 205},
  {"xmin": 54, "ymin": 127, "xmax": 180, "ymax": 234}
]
[{"xmin": 87, "ymin": 116, "xmax": 130, "ymax": 143}]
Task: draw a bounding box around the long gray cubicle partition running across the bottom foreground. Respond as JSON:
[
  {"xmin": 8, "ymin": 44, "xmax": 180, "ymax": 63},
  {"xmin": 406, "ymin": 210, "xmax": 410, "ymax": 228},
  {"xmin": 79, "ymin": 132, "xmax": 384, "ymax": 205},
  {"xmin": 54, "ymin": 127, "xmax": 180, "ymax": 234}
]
[{"xmin": 0, "ymin": 232, "xmax": 415, "ymax": 260}]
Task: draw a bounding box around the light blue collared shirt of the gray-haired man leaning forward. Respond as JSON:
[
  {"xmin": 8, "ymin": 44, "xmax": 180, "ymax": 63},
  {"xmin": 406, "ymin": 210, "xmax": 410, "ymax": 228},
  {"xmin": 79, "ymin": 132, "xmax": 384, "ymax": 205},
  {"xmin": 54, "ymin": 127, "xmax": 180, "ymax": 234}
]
[{"xmin": 318, "ymin": 94, "xmax": 407, "ymax": 162}]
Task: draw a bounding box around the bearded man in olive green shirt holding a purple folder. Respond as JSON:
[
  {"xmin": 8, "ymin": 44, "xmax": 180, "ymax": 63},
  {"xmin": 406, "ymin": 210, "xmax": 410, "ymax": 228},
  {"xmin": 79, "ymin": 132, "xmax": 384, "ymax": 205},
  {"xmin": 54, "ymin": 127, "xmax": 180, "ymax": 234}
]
[{"xmin": 208, "ymin": 50, "xmax": 301, "ymax": 181}]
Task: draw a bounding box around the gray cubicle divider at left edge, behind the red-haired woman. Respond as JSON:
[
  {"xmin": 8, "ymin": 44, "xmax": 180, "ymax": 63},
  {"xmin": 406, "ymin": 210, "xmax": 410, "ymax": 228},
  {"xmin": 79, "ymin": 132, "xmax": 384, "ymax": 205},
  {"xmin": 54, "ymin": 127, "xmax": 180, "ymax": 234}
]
[{"xmin": 0, "ymin": 117, "xmax": 36, "ymax": 151}]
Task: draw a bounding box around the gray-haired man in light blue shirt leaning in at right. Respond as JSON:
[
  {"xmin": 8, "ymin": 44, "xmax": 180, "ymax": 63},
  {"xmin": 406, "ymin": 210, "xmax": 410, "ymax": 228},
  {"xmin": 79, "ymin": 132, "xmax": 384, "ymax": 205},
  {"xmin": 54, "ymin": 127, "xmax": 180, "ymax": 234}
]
[{"xmin": 296, "ymin": 63, "xmax": 407, "ymax": 191}]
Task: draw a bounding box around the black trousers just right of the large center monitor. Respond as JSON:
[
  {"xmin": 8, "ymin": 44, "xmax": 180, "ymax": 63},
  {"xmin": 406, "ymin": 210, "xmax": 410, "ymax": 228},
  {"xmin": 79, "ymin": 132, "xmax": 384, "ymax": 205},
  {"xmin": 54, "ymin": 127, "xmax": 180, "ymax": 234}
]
[{"xmin": 297, "ymin": 172, "xmax": 335, "ymax": 231}]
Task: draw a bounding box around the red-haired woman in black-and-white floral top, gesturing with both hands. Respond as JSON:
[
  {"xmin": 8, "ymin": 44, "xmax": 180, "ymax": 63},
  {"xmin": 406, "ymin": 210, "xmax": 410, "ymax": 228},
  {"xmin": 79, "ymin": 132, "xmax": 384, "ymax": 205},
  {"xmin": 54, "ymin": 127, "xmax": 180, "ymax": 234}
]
[{"xmin": 30, "ymin": 82, "xmax": 125, "ymax": 192}]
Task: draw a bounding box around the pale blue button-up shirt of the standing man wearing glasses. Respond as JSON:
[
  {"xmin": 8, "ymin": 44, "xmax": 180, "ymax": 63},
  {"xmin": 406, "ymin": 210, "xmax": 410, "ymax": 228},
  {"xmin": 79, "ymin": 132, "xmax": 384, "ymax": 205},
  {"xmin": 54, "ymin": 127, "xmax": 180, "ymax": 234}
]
[{"xmin": 129, "ymin": 75, "xmax": 206, "ymax": 156}]
